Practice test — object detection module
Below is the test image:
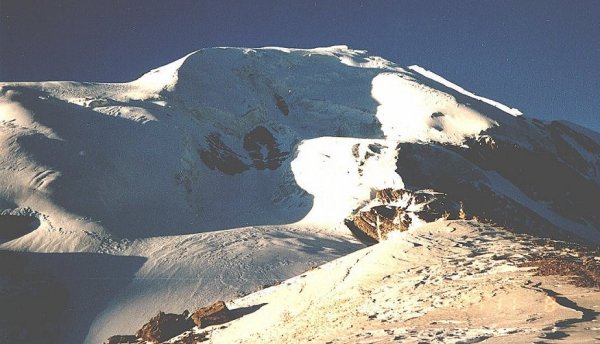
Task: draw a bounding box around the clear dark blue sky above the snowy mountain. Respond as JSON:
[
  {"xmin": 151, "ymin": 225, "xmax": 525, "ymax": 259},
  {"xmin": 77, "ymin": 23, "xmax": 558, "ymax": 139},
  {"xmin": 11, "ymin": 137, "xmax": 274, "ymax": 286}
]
[{"xmin": 0, "ymin": 0, "xmax": 600, "ymax": 131}]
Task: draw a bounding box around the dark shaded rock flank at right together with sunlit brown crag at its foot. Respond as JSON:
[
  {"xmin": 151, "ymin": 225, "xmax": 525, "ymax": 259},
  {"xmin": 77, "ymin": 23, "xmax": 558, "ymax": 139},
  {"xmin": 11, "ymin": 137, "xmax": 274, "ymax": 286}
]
[{"xmin": 346, "ymin": 114, "xmax": 600, "ymax": 241}]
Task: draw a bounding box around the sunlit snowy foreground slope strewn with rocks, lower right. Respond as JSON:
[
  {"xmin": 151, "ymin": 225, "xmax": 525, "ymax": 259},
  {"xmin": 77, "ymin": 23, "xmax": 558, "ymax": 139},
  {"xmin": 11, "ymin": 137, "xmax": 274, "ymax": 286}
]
[{"xmin": 108, "ymin": 221, "xmax": 600, "ymax": 344}]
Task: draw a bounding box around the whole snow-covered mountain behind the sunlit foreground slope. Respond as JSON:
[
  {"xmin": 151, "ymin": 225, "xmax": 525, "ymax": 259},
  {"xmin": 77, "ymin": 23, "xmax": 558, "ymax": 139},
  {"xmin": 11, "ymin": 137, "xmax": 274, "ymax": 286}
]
[{"xmin": 0, "ymin": 46, "xmax": 600, "ymax": 343}]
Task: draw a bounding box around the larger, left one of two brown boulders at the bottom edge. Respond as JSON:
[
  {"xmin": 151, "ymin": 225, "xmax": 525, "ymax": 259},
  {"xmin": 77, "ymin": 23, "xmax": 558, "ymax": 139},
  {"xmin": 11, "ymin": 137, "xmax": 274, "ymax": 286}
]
[{"xmin": 136, "ymin": 311, "xmax": 194, "ymax": 343}]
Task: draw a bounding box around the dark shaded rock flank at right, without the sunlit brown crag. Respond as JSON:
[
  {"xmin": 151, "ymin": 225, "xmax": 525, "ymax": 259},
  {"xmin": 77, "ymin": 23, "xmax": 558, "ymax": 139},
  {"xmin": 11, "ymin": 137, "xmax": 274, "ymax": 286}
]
[{"xmin": 396, "ymin": 123, "xmax": 600, "ymax": 239}]
